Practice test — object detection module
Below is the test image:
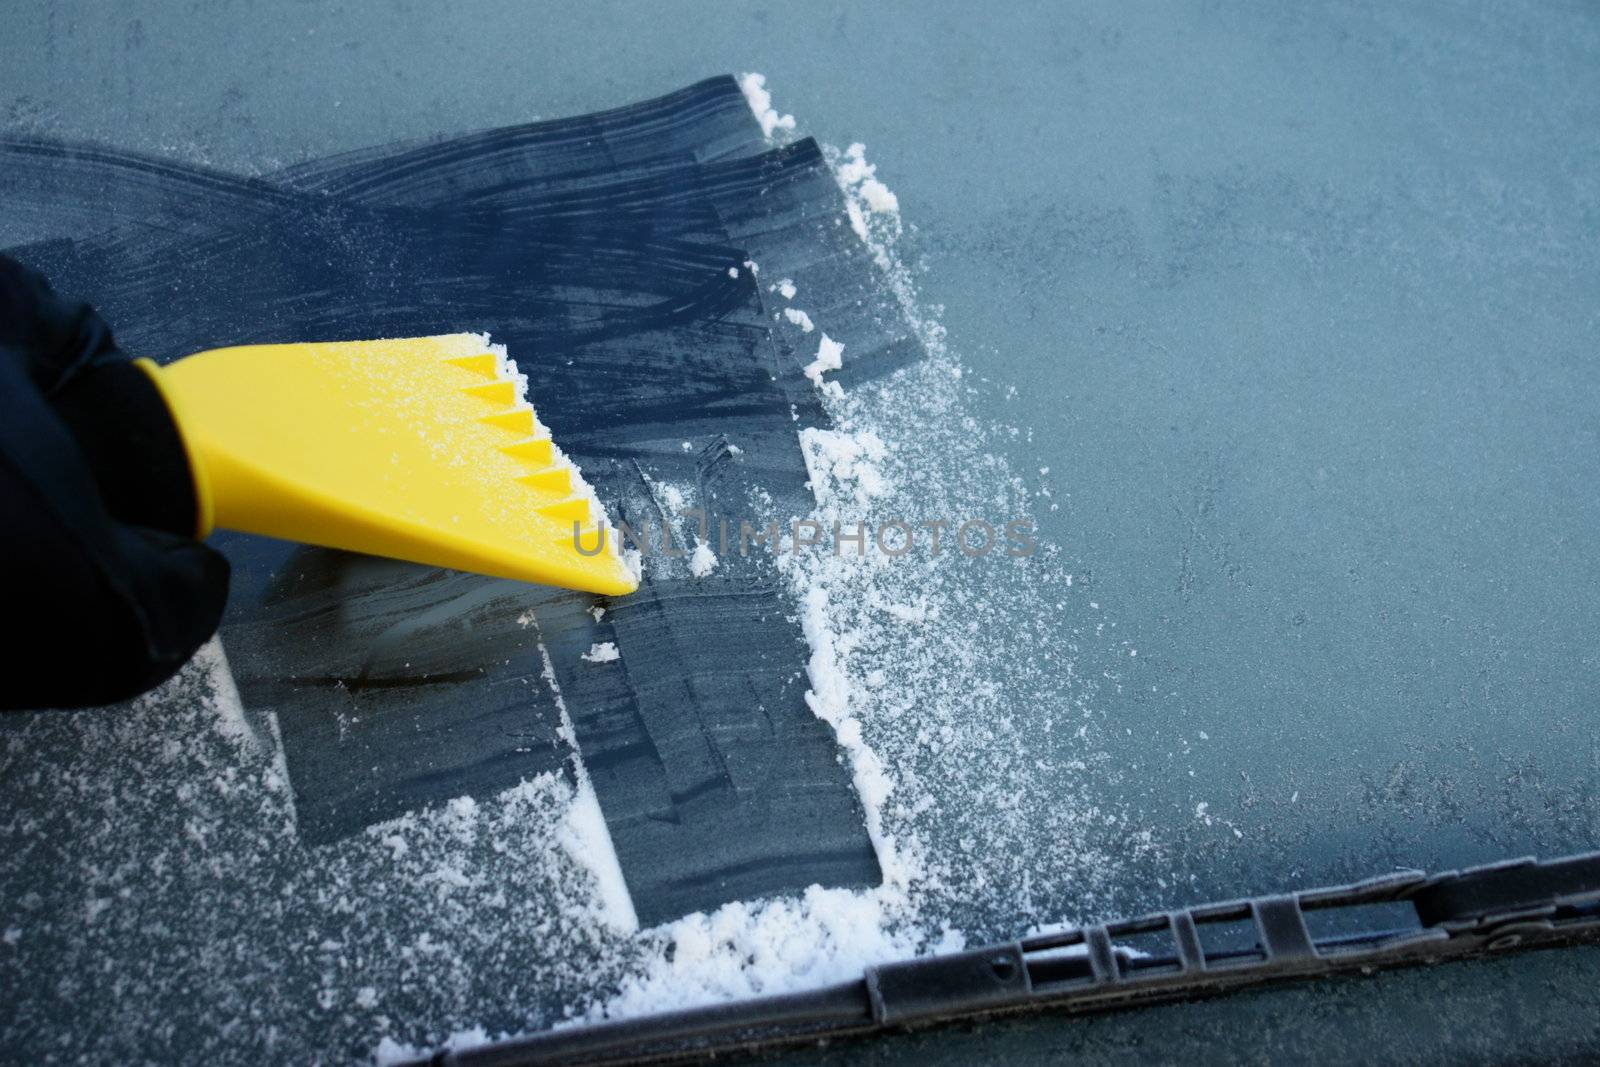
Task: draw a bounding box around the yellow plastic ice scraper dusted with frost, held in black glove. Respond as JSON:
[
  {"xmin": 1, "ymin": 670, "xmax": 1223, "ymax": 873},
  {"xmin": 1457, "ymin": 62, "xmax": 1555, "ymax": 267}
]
[{"xmin": 139, "ymin": 333, "xmax": 638, "ymax": 593}]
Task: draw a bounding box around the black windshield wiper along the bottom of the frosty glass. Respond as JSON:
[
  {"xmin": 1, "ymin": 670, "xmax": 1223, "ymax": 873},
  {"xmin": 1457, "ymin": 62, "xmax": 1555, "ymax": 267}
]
[{"xmin": 424, "ymin": 853, "xmax": 1600, "ymax": 1067}]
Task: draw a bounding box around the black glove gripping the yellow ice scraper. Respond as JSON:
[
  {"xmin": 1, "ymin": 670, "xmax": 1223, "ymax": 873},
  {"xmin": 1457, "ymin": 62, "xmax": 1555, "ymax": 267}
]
[{"xmin": 0, "ymin": 256, "xmax": 229, "ymax": 709}]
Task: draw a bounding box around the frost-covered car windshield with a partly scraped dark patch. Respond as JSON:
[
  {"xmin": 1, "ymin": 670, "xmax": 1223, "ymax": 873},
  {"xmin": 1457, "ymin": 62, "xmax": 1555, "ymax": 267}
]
[{"xmin": 0, "ymin": 0, "xmax": 1600, "ymax": 1062}]
